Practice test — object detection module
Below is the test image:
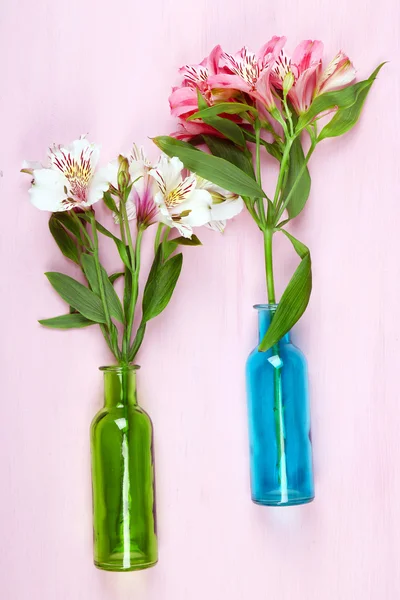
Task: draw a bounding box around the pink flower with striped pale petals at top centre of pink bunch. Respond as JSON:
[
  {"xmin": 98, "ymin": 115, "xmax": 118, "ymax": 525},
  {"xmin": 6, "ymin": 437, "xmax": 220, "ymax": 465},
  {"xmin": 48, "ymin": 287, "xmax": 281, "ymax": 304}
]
[{"xmin": 208, "ymin": 36, "xmax": 286, "ymax": 109}]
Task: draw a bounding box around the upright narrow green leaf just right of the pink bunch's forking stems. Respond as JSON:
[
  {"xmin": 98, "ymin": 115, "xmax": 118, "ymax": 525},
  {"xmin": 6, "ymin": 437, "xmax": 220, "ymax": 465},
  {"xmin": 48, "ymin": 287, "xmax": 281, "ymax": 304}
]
[{"xmin": 282, "ymin": 136, "xmax": 311, "ymax": 219}]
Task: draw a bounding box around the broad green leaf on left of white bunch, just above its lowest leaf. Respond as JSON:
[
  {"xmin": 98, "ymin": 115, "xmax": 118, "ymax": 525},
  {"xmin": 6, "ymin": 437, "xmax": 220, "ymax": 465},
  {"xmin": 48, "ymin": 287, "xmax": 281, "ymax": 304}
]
[{"xmin": 45, "ymin": 272, "xmax": 106, "ymax": 323}]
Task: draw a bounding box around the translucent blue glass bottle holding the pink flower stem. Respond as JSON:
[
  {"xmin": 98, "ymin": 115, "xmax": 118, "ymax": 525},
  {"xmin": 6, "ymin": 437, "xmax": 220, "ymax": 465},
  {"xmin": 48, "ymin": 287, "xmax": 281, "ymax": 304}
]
[{"xmin": 246, "ymin": 304, "xmax": 314, "ymax": 506}]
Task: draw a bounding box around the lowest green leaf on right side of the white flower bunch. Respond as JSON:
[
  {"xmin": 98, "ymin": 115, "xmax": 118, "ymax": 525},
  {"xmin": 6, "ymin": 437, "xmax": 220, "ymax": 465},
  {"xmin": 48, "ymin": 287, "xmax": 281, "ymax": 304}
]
[{"xmin": 142, "ymin": 245, "xmax": 183, "ymax": 321}]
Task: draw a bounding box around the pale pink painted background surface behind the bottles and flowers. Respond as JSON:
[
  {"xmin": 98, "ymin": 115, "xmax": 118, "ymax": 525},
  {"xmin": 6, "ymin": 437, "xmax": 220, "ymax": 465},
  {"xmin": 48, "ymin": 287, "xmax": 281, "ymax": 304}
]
[{"xmin": 0, "ymin": 0, "xmax": 400, "ymax": 600}]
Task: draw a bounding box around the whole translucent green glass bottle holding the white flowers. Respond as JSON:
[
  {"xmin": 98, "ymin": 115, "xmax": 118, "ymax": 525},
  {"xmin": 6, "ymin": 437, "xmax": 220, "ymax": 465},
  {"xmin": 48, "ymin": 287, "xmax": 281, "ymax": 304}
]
[{"xmin": 91, "ymin": 365, "xmax": 157, "ymax": 571}]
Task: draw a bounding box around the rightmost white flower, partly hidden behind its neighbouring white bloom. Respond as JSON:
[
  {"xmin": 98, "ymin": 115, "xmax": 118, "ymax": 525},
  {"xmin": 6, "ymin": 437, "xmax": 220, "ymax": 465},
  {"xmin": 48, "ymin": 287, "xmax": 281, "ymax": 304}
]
[{"xmin": 196, "ymin": 176, "xmax": 244, "ymax": 233}]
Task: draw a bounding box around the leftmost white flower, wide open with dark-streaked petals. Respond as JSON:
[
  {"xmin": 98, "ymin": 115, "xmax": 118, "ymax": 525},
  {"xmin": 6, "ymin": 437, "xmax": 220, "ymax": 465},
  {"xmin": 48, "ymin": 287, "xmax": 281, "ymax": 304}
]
[{"xmin": 23, "ymin": 136, "xmax": 111, "ymax": 212}]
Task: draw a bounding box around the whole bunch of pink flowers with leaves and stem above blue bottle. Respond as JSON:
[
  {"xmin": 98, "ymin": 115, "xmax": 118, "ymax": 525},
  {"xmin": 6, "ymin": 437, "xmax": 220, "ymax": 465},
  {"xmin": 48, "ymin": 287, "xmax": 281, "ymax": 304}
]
[{"xmin": 155, "ymin": 36, "xmax": 382, "ymax": 351}]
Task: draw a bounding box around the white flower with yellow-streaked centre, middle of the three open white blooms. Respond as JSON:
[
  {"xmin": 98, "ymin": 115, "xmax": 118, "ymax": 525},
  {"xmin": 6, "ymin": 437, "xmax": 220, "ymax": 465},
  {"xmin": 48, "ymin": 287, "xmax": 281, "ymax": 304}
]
[{"xmin": 149, "ymin": 156, "xmax": 210, "ymax": 238}]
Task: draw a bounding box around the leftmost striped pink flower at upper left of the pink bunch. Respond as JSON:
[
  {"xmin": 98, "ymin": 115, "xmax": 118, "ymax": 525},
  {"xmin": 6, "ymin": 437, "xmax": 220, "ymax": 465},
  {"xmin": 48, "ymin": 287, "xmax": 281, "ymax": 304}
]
[{"xmin": 169, "ymin": 46, "xmax": 222, "ymax": 118}]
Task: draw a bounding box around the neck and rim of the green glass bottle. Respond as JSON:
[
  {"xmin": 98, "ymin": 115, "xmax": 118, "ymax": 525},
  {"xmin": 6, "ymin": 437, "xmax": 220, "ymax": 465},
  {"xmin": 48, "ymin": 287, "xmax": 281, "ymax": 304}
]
[{"xmin": 103, "ymin": 367, "xmax": 137, "ymax": 408}]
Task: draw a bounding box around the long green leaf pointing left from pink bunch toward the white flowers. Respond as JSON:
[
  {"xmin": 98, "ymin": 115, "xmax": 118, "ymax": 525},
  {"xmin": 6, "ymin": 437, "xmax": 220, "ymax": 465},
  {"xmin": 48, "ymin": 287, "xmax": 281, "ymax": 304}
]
[{"xmin": 153, "ymin": 136, "xmax": 265, "ymax": 198}]
